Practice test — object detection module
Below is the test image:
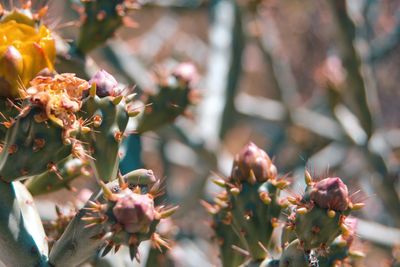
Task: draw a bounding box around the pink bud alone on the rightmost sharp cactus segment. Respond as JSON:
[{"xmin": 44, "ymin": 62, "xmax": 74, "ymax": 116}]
[{"xmin": 310, "ymin": 177, "xmax": 349, "ymax": 211}]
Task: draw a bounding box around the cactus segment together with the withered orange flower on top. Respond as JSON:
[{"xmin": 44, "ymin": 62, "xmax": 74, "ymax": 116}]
[{"xmin": 0, "ymin": 74, "xmax": 89, "ymax": 182}]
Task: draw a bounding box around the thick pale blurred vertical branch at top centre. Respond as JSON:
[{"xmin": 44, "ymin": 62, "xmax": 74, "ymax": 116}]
[{"xmin": 198, "ymin": 0, "xmax": 242, "ymax": 150}]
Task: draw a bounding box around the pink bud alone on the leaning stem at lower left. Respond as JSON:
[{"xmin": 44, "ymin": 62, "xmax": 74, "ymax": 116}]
[{"xmin": 113, "ymin": 193, "xmax": 155, "ymax": 233}]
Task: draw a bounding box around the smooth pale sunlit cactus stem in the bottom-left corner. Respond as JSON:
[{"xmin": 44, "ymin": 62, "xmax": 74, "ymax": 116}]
[{"xmin": 0, "ymin": 181, "xmax": 48, "ymax": 266}]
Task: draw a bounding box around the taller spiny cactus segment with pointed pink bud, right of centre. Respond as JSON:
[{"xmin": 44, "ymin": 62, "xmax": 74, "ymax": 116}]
[{"xmin": 208, "ymin": 143, "xmax": 289, "ymax": 266}]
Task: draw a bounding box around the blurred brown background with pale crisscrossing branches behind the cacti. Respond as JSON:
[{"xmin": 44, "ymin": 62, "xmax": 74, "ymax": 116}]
[{"xmin": 32, "ymin": 0, "xmax": 400, "ymax": 266}]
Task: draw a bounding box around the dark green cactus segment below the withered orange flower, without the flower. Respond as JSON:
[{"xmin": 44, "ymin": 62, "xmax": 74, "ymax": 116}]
[{"xmin": 0, "ymin": 109, "xmax": 72, "ymax": 182}]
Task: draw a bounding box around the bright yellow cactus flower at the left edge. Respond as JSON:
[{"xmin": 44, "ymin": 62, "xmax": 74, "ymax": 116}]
[{"xmin": 0, "ymin": 10, "xmax": 56, "ymax": 98}]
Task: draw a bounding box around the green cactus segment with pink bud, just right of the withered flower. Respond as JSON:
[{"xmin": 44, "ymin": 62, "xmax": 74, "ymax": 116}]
[{"xmin": 82, "ymin": 71, "xmax": 136, "ymax": 181}]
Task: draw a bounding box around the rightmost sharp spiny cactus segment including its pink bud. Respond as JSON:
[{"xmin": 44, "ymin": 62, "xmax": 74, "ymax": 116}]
[{"xmin": 288, "ymin": 175, "xmax": 363, "ymax": 250}]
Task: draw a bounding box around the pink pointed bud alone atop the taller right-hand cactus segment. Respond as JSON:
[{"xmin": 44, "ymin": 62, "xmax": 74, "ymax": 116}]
[{"xmin": 231, "ymin": 143, "xmax": 277, "ymax": 183}]
